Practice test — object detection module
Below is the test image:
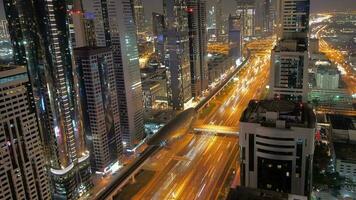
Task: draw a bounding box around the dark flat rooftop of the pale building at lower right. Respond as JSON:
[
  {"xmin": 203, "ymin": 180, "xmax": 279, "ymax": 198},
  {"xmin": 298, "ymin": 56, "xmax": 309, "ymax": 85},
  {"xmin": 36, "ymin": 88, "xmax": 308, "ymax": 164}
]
[{"xmin": 240, "ymin": 100, "xmax": 316, "ymax": 128}]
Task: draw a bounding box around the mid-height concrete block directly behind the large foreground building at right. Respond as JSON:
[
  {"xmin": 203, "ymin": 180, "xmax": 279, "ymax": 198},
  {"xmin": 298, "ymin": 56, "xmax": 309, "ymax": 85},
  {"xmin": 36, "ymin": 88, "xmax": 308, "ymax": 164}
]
[{"xmin": 269, "ymin": 40, "xmax": 309, "ymax": 102}]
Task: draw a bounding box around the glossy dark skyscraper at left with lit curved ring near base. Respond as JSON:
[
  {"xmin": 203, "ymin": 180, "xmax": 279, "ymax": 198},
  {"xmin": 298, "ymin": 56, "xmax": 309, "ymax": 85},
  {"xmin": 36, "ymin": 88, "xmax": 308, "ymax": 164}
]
[{"xmin": 4, "ymin": 0, "xmax": 91, "ymax": 199}]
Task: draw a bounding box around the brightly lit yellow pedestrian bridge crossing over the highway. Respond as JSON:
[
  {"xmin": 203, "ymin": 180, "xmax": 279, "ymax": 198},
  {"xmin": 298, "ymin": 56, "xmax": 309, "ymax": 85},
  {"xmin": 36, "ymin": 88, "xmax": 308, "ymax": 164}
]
[{"xmin": 193, "ymin": 124, "xmax": 239, "ymax": 136}]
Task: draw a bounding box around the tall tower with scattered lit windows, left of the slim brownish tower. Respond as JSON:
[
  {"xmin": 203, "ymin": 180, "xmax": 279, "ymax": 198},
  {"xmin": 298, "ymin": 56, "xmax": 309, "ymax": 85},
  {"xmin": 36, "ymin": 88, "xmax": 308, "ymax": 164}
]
[{"xmin": 163, "ymin": 0, "xmax": 192, "ymax": 110}]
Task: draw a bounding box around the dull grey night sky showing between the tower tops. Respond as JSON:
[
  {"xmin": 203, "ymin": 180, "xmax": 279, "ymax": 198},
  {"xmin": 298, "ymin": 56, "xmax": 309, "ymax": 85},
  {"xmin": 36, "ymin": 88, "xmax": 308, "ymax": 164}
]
[{"xmin": 0, "ymin": 0, "xmax": 356, "ymax": 18}]
